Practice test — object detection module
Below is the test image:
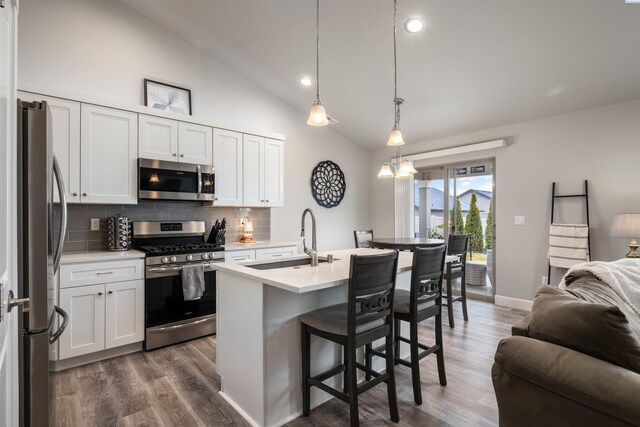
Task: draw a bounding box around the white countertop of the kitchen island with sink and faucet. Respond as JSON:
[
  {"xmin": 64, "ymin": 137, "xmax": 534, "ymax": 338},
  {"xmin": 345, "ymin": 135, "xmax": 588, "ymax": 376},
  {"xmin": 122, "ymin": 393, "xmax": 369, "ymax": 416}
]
[{"xmin": 214, "ymin": 248, "xmax": 458, "ymax": 293}]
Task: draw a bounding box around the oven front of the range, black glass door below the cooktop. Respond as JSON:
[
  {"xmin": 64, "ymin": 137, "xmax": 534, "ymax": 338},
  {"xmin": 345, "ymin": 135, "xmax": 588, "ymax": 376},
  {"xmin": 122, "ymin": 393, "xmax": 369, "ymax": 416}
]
[{"xmin": 144, "ymin": 258, "xmax": 224, "ymax": 350}]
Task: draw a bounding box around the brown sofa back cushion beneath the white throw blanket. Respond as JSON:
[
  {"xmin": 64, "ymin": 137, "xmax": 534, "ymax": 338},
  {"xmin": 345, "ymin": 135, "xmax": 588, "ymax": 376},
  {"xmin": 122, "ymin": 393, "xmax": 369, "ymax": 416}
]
[{"xmin": 529, "ymin": 286, "xmax": 640, "ymax": 373}]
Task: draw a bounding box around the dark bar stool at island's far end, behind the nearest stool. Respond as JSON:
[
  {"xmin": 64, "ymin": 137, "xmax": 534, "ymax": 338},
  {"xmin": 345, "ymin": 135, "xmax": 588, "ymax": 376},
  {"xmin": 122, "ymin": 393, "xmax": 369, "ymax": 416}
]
[{"xmin": 365, "ymin": 245, "xmax": 447, "ymax": 405}]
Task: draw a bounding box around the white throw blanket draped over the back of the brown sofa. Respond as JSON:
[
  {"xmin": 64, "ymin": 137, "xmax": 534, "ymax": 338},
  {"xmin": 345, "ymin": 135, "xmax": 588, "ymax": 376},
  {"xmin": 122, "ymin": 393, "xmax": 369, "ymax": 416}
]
[{"xmin": 559, "ymin": 258, "xmax": 640, "ymax": 316}]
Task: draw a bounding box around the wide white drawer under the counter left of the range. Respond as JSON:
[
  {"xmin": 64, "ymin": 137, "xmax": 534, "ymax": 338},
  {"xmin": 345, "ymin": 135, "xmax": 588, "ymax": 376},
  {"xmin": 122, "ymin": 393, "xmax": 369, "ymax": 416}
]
[{"xmin": 60, "ymin": 260, "xmax": 144, "ymax": 288}]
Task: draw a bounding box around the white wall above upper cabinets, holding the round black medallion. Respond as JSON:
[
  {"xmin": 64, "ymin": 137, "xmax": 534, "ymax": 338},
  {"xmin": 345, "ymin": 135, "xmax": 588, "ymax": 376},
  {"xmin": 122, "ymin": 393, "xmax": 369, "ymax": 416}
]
[{"xmin": 18, "ymin": 0, "xmax": 371, "ymax": 250}]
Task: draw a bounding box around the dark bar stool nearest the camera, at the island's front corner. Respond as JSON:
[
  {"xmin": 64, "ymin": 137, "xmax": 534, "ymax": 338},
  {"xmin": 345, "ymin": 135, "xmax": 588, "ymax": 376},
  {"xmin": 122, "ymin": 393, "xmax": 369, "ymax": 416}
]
[{"xmin": 300, "ymin": 251, "xmax": 400, "ymax": 426}]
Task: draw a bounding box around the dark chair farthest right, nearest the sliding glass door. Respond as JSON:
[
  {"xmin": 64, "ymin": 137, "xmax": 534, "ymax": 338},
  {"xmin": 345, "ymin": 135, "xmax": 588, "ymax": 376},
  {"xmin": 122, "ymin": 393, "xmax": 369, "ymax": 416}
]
[{"xmin": 443, "ymin": 234, "xmax": 469, "ymax": 328}]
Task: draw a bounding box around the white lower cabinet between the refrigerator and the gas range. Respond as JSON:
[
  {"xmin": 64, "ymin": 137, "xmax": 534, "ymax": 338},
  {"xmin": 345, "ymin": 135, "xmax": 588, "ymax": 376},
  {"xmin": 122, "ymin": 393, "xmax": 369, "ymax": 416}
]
[{"xmin": 58, "ymin": 260, "xmax": 144, "ymax": 360}]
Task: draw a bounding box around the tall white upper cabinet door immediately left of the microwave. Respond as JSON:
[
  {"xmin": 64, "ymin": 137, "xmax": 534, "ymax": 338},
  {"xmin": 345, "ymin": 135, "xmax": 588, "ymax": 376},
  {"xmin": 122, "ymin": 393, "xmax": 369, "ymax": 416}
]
[{"xmin": 80, "ymin": 104, "xmax": 138, "ymax": 204}]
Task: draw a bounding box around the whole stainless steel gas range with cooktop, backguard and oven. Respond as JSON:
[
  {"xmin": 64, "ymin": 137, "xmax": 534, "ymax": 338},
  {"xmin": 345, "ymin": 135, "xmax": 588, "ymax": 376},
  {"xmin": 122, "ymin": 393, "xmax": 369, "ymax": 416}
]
[{"xmin": 133, "ymin": 221, "xmax": 224, "ymax": 350}]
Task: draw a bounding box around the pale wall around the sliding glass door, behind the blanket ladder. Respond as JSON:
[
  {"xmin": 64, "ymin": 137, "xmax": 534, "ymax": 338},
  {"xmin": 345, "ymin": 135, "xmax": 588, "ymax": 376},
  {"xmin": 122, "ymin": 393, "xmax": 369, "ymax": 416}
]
[{"xmin": 371, "ymin": 100, "xmax": 640, "ymax": 299}]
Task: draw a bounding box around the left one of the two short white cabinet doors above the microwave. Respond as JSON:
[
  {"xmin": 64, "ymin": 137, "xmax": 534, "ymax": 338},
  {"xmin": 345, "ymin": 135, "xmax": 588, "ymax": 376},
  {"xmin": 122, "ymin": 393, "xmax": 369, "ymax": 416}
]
[{"xmin": 138, "ymin": 114, "xmax": 178, "ymax": 161}]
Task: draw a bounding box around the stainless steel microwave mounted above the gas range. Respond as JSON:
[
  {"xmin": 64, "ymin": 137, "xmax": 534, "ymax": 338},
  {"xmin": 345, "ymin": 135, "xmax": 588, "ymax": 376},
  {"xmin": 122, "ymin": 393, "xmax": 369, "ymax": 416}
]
[{"xmin": 138, "ymin": 159, "xmax": 215, "ymax": 202}]
